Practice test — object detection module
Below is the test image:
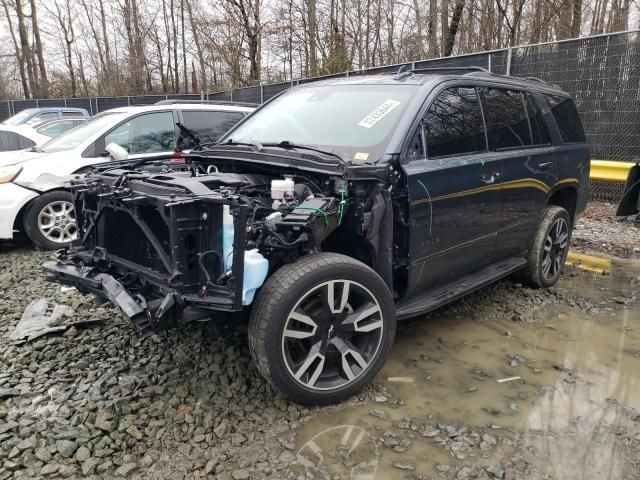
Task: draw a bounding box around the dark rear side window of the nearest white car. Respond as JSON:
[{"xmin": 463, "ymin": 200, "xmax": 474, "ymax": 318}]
[{"xmin": 178, "ymin": 110, "xmax": 244, "ymax": 150}]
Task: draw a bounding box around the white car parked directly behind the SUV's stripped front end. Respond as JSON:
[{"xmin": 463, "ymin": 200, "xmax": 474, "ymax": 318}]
[{"xmin": 0, "ymin": 103, "xmax": 254, "ymax": 249}]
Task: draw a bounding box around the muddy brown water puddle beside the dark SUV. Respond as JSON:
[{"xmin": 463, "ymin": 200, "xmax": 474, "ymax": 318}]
[{"xmin": 287, "ymin": 262, "xmax": 640, "ymax": 480}]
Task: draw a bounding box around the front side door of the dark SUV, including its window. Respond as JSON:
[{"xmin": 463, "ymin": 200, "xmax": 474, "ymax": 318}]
[{"xmin": 404, "ymin": 86, "xmax": 502, "ymax": 295}]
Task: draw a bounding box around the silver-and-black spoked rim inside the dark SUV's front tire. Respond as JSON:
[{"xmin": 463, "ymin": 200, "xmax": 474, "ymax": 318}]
[{"xmin": 282, "ymin": 280, "xmax": 384, "ymax": 390}]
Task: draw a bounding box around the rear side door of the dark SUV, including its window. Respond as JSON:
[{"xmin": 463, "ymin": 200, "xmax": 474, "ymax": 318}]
[{"xmin": 479, "ymin": 87, "xmax": 557, "ymax": 258}]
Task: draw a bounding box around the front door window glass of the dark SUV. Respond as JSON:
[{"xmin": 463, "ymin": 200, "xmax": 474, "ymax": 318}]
[{"xmin": 424, "ymin": 87, "xmax": 486, "ymax": 158}]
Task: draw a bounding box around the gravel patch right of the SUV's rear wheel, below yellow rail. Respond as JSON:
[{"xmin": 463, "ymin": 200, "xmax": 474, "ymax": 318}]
[{"xmin": 573, "ymin": 202, "xmax": 640, "ymax": 258}]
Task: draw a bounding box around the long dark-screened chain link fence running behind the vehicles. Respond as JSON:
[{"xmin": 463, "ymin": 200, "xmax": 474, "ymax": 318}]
[{"xmin": 0, "ymin": 30, "xmax": 640, "ymax": 199}]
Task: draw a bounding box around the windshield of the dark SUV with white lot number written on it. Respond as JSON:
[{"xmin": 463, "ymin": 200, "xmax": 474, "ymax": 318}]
[{"xmin": 222, "ymin": 85, "xmax": 417, "ymax": 162}]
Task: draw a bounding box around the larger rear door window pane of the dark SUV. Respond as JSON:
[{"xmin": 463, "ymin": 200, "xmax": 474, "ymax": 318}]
[{"xmin": 481, "ymin": 88, "xmax": 532, "ymax": 150}]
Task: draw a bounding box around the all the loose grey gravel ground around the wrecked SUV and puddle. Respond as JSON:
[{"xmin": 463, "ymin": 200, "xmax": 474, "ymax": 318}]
[{"xmin": 0, "ymin": 201, "xmax": 640, "ymax": 480}]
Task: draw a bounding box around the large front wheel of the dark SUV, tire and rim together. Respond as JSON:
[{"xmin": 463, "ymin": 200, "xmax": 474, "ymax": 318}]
[{"xmin": 249, "ymin": 253, "xmax": 396, "ymax": 405}]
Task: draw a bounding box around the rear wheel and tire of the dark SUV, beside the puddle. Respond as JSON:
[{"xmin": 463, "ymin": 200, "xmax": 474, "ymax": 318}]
[{"xmin": 515, "ymin": 205, "xmax": 572, "ymax": 288}]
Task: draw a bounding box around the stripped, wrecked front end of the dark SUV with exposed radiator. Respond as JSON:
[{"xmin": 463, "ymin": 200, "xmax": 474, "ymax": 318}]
[{"xmin": 43, "ymin": 161, "xmax": 341, "ymax": 334}]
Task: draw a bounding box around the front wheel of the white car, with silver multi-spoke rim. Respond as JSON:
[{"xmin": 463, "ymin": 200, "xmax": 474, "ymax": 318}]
[{"xmin": 24, "ymin": 190, "xmax": 78, "ymax": 250}]
